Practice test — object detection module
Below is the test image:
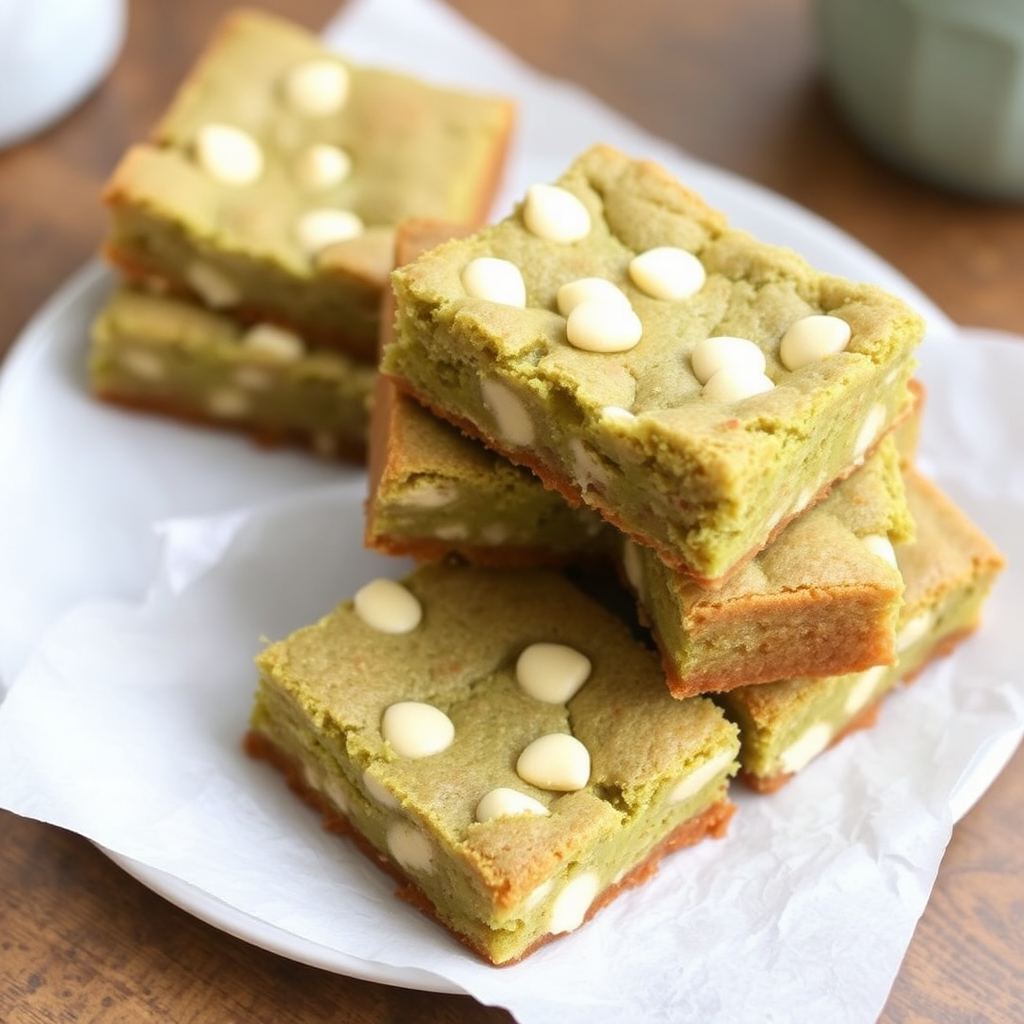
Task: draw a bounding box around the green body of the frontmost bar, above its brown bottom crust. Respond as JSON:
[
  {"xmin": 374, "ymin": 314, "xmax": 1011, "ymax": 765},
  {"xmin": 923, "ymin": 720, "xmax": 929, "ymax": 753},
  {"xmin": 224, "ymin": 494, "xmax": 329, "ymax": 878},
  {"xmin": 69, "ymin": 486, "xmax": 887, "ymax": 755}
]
[{"xmin": 253, "ymin": 565, "xmax": 738, "ymax": 925}]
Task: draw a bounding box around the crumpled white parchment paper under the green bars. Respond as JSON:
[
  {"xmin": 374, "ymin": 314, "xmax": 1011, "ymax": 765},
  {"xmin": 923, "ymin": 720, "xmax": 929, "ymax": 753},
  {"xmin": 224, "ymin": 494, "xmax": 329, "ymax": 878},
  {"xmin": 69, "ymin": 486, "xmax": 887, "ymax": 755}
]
[{"xmin": 0, "ymin": 0, "xmax": 1024, "ymax": 1024}]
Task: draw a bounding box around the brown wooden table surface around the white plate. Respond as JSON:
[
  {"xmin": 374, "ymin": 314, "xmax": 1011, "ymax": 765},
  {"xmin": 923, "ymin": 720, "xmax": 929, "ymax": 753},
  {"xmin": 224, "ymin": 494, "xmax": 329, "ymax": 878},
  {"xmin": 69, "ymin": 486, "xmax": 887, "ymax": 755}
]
[{"xmin": 0, "ymin": 0, "xmax": 1024, "ymax": 1024}]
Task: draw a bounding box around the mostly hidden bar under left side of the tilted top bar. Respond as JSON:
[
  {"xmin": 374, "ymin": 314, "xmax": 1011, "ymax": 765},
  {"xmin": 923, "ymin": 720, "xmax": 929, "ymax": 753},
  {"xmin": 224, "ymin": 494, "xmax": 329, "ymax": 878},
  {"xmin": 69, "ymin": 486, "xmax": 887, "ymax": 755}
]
[{"xmin": 365, "ymin": 219, "xmax": 614, "ymax": 567}]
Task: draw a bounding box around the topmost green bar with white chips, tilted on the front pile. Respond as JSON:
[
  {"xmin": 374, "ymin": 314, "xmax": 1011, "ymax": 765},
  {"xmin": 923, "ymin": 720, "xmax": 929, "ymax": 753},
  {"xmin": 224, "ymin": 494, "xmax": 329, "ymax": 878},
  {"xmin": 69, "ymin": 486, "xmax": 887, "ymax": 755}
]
[{"xmin": 382, "ymin": 146, "xmax": 924, "ymax": 587}]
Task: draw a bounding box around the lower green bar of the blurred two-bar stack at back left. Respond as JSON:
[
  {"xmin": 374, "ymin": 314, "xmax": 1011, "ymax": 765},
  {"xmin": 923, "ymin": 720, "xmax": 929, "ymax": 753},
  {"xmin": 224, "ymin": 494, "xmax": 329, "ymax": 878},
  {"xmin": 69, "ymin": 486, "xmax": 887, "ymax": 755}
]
[{"xmin": 89, "ymin": 288, "xmax": 377, "ymax": 462}]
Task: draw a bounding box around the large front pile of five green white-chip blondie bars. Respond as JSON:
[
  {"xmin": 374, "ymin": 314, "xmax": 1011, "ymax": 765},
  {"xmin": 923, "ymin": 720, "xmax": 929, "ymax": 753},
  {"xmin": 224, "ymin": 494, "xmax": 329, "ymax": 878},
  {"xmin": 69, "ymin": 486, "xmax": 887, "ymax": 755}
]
[{"xmin": 241, "ymin": 146, "xmax": 1001, "ymax": 964}]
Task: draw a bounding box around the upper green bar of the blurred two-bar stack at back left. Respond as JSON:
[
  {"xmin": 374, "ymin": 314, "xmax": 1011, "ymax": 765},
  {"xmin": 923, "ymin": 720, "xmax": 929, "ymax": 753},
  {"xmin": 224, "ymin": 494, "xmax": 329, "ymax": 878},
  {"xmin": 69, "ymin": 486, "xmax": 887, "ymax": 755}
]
[{"xmin": 105, "ymin": 10, "xmax": 513, "ymax": 344}]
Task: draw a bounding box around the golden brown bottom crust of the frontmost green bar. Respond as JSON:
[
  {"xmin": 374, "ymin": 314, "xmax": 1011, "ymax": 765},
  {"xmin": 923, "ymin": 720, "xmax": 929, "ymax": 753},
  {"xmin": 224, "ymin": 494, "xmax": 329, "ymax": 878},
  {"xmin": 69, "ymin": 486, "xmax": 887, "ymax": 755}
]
[{"xmin": 243, "ymin": 730, "xmax": 735, "ymax": 967}]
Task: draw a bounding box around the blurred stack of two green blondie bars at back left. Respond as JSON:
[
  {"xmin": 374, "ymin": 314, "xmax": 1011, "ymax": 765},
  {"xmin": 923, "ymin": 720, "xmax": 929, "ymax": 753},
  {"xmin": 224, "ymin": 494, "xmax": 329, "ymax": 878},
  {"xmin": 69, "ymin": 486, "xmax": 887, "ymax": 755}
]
[{"xmin": 90, "ymin": 10, "xmax": 514, "ymax": 460}]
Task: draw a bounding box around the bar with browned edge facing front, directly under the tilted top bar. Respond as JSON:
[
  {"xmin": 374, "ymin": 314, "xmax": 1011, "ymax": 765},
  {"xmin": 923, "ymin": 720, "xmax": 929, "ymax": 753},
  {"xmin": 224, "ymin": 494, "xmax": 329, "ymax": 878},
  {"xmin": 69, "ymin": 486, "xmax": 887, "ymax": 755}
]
[{"xmin": 618, "ymin": 437, "xmax": 914, "ymax": 696}]
